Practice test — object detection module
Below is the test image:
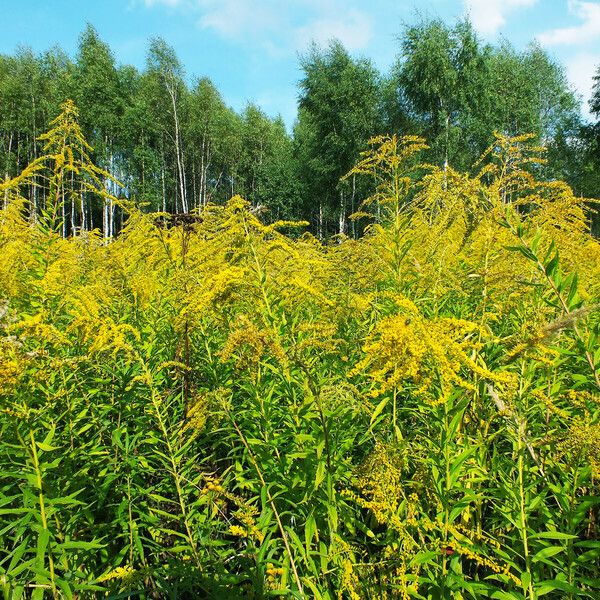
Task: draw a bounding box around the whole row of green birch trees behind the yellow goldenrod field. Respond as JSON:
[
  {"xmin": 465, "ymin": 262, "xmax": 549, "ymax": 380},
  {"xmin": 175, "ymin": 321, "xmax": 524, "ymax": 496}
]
[{"xmin": 0, "ymin": 20, "xmax": 600, "ymax": 237}]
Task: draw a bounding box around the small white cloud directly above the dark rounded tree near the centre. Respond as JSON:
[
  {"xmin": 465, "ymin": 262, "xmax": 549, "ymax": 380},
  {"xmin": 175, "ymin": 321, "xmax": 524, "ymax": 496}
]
[{"xmin": 296, "ymin": 10, "xmax": 372, "ymax": 50}]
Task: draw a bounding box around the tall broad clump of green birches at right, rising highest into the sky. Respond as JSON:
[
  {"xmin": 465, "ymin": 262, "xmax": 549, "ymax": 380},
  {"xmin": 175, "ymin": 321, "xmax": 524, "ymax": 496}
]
[{"xmin": 388, "ymin": 20, "xmax": 579, "ymax": 177}]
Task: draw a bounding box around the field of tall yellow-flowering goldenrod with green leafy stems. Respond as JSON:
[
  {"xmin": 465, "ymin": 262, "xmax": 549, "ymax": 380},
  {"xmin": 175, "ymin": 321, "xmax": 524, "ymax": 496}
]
[{"xmin": 0, "ymin": 97, "xmax": 600, "ymax": 600}]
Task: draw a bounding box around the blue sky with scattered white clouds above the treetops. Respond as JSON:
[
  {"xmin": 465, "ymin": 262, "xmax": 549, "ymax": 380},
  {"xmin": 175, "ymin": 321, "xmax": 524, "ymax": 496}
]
[{"xmin": 0, "ymin": 0, "xmax": 600, "ymax": 125}]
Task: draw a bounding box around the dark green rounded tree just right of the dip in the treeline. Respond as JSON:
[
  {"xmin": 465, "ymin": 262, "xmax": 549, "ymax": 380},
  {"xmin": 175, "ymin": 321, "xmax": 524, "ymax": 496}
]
[{"xmin": 294, "ymin": 41, "xmax": 381, "ymax": 236}]
